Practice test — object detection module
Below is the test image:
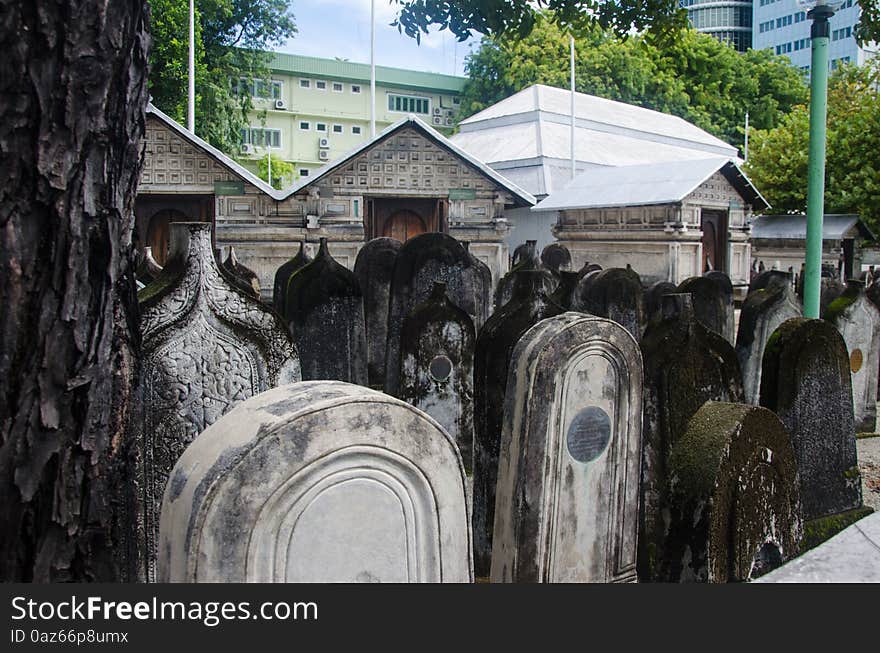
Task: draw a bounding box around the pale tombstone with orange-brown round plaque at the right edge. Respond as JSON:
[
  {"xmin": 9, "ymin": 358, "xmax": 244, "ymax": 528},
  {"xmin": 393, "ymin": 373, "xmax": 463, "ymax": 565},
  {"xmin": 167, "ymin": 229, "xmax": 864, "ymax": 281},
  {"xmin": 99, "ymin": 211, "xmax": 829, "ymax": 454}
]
[{"xmin": 823, "ymin": 279, "xmax": 880, "ymax": 433}]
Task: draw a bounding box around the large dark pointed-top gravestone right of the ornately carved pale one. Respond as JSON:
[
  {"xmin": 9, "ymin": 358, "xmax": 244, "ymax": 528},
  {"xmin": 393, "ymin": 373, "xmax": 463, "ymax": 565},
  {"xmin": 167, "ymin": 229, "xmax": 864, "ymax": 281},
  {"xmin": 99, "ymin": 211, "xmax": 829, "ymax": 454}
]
[{"xmin": 284, "ymin": 238, "xmax": 367, "ymax": 385}]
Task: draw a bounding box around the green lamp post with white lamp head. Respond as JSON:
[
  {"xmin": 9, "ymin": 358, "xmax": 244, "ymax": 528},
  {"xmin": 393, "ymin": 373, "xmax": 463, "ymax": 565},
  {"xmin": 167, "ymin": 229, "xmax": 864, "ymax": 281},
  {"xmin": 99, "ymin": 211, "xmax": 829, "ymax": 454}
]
[{"xmin": 798, "ymin": 0, "xmax": 843, "ymax": 318}]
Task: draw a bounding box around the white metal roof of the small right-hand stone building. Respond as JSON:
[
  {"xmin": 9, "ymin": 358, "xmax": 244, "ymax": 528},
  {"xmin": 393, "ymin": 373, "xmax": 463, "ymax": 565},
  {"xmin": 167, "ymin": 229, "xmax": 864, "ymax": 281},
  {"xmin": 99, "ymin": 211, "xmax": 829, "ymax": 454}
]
[{"xmin": 532, "ymin": 157, "xmax": 769, "ymax": 211}]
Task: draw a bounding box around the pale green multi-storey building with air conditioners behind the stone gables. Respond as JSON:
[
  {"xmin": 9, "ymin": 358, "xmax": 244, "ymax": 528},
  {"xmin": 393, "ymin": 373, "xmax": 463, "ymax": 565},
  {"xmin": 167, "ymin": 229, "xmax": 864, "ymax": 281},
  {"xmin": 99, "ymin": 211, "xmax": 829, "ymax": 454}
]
[{"xmin": 242, "ymin": 53, "xmax": 465, "ymax": 183}]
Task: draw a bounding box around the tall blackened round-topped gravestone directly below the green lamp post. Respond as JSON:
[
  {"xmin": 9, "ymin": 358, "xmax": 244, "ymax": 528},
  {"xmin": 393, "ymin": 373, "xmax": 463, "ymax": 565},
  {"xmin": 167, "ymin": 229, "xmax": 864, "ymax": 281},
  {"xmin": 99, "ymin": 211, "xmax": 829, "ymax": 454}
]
[{"xmin": 761, "ymin": 318, "xmax": 862, "ymax": 520}]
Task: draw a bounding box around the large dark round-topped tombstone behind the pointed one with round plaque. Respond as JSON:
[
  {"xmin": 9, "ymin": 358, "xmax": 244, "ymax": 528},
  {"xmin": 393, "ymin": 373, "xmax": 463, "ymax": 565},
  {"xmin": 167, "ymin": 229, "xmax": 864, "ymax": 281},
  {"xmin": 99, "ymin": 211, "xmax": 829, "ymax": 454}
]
[{"xmin": 385, "ymin": 233, "xmax": 489, "ymax": 396}]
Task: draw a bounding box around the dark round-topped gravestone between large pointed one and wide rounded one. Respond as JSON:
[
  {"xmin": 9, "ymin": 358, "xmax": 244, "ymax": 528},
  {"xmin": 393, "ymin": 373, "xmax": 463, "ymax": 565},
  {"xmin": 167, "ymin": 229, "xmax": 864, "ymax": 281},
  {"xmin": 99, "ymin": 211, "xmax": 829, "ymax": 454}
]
[{"xmin": 354, "ymin": 238, "xmax": 403, "ymax": 389}]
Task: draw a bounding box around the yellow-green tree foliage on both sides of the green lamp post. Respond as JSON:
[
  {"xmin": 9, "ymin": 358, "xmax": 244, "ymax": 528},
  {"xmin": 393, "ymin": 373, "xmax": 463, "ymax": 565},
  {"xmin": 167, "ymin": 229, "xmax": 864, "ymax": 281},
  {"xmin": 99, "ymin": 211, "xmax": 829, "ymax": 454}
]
[{"xmin": 746, "ymin": 61, "xmax": 880, "ymax": 231}]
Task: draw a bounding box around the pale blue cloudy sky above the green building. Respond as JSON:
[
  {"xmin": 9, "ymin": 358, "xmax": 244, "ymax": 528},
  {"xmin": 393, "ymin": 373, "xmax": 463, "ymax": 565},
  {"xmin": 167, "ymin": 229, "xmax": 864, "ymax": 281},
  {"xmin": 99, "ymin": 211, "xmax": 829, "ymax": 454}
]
[{"xmin": 278, "ymin": 0, "xmax": 478, "ymax": 75}]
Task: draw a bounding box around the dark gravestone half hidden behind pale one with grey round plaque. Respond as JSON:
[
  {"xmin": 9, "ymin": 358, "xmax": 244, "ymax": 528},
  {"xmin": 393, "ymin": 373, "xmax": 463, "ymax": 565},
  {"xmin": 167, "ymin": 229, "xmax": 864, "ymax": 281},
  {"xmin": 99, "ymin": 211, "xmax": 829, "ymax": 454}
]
[{"xmin": 473, "ymin": 270, "xmax": 562, "ymax": 578}]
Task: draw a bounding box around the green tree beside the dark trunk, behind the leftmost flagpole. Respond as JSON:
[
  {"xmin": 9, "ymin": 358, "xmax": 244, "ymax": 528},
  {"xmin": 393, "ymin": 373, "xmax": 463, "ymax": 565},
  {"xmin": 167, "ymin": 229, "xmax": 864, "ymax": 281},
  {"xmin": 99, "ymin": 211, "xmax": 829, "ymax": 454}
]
[{"xmin": 149, "ymin": 0, "xmax": 296, "ymax": 152}]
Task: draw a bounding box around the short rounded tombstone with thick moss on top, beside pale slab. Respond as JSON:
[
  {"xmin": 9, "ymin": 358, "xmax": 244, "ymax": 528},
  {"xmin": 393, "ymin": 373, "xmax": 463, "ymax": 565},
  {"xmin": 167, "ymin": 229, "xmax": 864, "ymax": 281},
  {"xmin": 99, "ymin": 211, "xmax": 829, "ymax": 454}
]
[{"xmin": 658, "ymin": 401, "xmax": 803, "ymax": 583}]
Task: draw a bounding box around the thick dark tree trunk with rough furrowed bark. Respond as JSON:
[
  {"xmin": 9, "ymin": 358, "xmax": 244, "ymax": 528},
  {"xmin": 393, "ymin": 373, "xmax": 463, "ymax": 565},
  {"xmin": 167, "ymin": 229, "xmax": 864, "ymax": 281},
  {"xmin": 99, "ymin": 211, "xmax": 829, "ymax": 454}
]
[{"xmin": 0, "ymin": 0, "xmax": 148, "ymax": 582}]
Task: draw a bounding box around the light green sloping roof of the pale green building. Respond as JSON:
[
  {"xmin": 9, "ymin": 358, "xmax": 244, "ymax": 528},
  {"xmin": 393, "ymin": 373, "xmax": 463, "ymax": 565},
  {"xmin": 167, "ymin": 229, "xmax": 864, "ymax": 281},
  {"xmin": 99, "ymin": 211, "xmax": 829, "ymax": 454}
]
[{"xmin": 269, "ymin": 52, "xmax": 467, "ymax": 93}]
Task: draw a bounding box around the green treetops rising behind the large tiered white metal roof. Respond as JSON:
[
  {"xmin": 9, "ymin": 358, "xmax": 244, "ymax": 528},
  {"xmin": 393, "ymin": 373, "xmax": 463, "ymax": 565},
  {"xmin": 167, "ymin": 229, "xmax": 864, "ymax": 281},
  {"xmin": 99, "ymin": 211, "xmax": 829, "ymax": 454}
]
[{"xmin": 461, "ymin": 14, "xmax": 807, "ymax": 150}]
